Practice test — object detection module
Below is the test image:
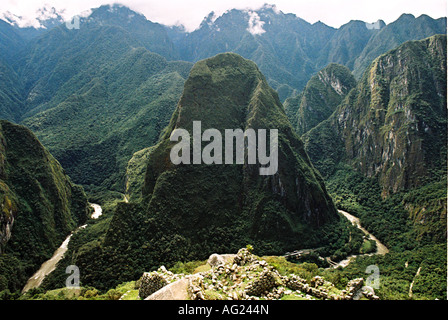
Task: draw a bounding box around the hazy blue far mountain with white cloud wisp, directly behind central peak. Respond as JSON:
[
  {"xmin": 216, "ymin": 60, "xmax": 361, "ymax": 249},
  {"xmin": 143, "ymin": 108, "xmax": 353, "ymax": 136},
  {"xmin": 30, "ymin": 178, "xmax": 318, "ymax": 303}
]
[{"xmin": 168, "ymin": 6, "xmax": 335, "ymax": 100}]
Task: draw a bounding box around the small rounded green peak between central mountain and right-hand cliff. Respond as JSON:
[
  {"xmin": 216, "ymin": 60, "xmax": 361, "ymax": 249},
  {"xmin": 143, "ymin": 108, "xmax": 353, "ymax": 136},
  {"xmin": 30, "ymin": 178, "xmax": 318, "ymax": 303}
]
[{"xmin": 285, "ymin": 64, "xmax": 356, "ymax": 136}]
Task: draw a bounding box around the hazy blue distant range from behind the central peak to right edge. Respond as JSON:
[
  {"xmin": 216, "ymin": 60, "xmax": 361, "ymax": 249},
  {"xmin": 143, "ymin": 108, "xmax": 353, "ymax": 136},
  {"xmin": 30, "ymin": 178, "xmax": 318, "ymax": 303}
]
[{"xmin": 169, "ymin": 5, "xmax": 446, "ymax": 101}]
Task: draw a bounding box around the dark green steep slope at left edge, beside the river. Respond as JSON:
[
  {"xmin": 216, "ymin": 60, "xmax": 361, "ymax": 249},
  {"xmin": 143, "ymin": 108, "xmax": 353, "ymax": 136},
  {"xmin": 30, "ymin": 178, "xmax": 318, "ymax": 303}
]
[{"xmin": 0, "ymin": 120, "xmax": 90, "ymax": 291}]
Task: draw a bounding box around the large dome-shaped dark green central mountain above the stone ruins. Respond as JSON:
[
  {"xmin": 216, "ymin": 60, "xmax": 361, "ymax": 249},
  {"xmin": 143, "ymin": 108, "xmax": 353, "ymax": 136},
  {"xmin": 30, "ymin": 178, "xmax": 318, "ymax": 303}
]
[{"xmin": 62, "ymin": 54, "xmax": 348, "ymax": 288}]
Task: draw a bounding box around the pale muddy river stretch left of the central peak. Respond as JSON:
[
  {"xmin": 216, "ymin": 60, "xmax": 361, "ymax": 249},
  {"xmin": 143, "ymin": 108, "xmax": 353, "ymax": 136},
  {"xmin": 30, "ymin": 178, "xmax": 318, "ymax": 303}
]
[{"xmin": 22, "ymin": 203, "xmax": 103, "ymax": 293}]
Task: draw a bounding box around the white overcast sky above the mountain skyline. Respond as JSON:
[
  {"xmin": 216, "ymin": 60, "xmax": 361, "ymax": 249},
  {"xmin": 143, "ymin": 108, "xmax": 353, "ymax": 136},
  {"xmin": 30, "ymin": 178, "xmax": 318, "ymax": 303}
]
[{"xmin": 0, "ymin": 0, "xmax": 447, "ymax": 31}]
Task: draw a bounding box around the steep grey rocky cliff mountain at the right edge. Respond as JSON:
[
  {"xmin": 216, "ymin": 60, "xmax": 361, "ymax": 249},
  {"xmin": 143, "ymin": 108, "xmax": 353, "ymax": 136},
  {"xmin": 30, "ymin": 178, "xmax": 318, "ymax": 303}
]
[{"xmin": 305, "ymin": 35, "xmax": 447, "ymax": 196}]
